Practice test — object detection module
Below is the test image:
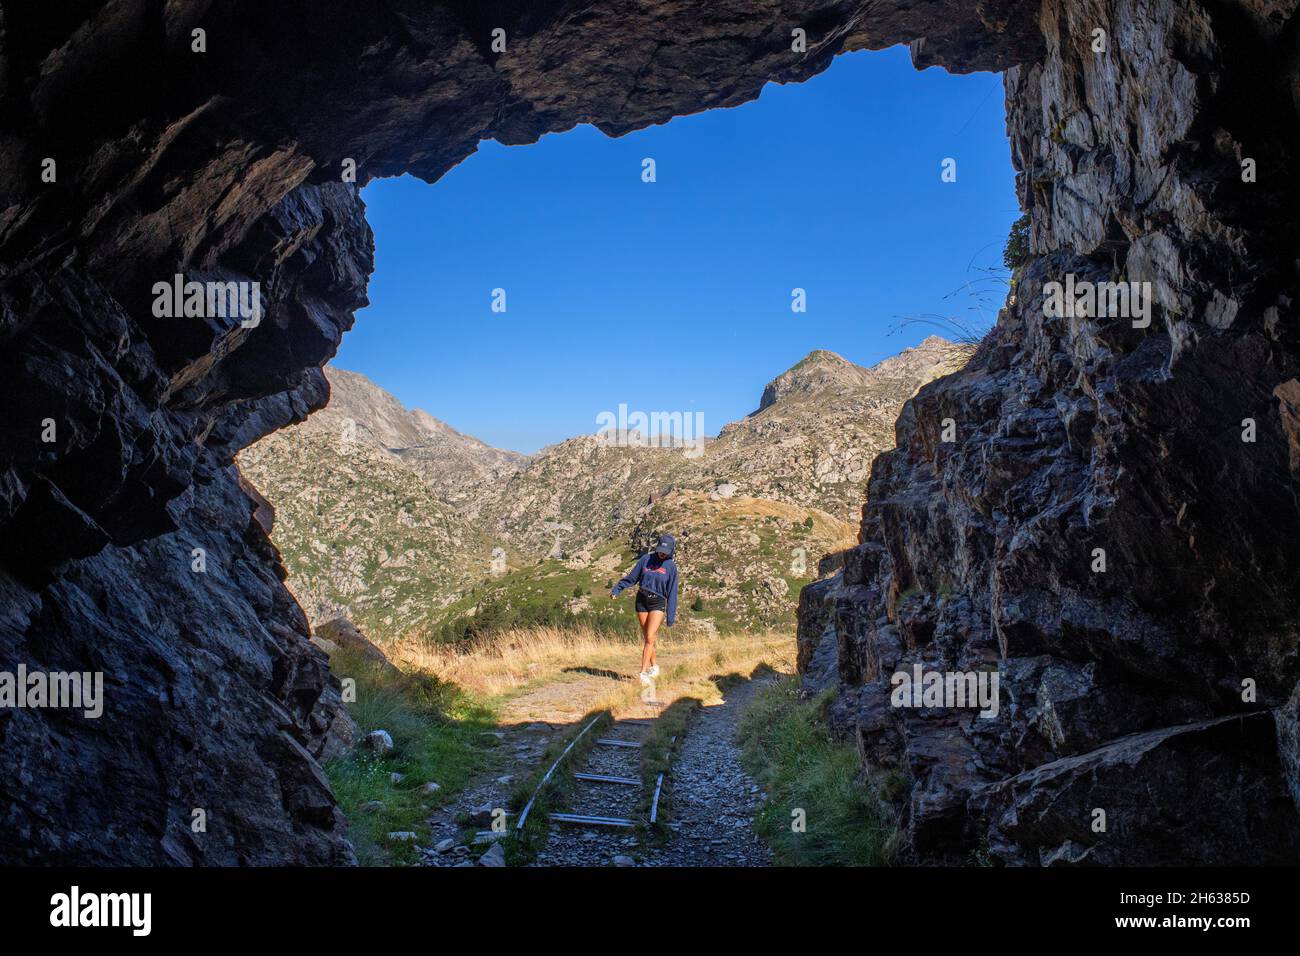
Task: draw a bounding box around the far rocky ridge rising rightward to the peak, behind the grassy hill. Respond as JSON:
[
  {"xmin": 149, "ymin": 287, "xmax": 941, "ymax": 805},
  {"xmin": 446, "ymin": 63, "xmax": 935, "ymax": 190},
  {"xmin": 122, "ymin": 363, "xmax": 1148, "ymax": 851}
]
[{"xmin": 482, "ymin": 337, "xmax": 966, "ymax": 561}]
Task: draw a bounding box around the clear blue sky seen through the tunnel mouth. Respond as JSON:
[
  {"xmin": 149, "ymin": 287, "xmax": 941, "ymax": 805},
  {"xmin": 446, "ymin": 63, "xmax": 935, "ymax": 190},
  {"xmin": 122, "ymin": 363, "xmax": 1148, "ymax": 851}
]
[{"xmin": 335, "ymin": 47, "xmax": 1018, "ymax": 453}]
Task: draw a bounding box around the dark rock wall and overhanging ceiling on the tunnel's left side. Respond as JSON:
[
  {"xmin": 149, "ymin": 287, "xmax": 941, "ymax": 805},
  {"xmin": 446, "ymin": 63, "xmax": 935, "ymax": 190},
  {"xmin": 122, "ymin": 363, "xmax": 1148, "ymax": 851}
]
[{"xmin": 0, "ymin": 0, "xmax": 1041, "ymax": 864}]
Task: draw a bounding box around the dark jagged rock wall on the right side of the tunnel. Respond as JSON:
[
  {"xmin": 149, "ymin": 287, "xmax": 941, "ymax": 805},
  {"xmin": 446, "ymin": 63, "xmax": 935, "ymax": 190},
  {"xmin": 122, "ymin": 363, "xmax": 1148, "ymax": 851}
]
[{"xmin": 800, "ymin": 0, "xmax": 1300, "ymax": 864}]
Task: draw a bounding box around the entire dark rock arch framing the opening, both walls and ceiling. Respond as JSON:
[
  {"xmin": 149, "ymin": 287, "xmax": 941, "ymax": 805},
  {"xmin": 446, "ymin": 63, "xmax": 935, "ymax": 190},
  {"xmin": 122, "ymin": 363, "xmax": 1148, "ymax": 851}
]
[{"xmin": 0, "ymin": 0, "xmax": 1300, "ymax": 864}]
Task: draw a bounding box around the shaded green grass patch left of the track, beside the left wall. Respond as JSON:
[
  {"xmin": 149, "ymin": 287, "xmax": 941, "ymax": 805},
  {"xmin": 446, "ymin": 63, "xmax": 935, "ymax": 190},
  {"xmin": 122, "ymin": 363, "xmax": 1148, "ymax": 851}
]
[{"xmin": 325, "ymin": 648, "xmax": 495, "ymax": 866}]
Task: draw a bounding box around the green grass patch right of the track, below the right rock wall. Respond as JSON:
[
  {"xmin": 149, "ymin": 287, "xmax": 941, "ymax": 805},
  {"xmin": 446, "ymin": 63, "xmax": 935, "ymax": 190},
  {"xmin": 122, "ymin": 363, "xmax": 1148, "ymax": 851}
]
[{"xmin": 740, "ymin": 678, "xmax": 898, "ymax": 866}]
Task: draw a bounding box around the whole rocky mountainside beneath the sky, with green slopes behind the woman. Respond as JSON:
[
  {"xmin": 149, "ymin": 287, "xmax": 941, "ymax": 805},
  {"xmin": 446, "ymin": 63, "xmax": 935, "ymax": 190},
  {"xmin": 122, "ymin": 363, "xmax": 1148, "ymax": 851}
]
[{"xmin": 239, "ymin": 338, "xmax": 961, "ymax": 639}]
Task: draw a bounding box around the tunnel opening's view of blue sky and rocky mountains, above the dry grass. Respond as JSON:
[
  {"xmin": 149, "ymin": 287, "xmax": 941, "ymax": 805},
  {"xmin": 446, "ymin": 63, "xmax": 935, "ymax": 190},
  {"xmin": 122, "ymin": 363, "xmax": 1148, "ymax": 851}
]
[{"xmin": 239, "ymin": 48, "xmax": 1019, "ymax": 655}]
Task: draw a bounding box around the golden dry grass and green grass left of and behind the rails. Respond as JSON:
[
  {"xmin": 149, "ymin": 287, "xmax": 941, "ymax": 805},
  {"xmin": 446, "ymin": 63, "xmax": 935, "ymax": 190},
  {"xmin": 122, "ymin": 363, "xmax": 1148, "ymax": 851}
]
[{"xmin": 326, "ymin": 627, "xmax": 794, "ymax": 866}]
